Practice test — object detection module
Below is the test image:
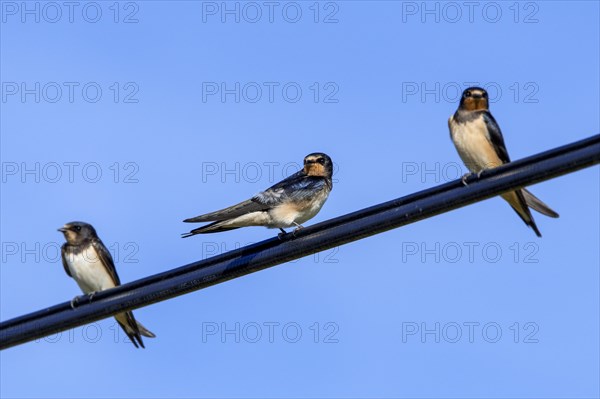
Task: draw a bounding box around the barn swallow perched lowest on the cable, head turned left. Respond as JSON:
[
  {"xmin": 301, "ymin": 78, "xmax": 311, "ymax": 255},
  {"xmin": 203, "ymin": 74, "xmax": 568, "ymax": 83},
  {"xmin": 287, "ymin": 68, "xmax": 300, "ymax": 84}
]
[{"xmin": 58, "ymin": 222, "xmax": 155, "ymax": 348}]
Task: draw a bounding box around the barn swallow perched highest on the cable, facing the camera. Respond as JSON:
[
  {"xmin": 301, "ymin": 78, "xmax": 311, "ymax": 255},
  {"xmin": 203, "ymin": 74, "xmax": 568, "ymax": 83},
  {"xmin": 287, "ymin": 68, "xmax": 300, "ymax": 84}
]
[{"xmin": 448, "ymin": 87, "xmax": 558, "ymax": 237}]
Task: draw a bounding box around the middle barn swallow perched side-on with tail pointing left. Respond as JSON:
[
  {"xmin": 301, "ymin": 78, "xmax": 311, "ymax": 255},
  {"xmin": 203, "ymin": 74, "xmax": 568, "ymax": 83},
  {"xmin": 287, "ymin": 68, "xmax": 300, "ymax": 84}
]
[{"xmin": 182, "ymin": 152, "xmax": 333, "ymax": 237}]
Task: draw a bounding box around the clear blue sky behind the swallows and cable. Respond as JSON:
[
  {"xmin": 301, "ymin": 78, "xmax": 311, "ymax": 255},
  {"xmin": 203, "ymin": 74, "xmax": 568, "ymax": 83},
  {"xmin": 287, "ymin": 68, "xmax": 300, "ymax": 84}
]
[{"xmin": 0, "ymin": 1, "xmax": 600, "ymax": 398}]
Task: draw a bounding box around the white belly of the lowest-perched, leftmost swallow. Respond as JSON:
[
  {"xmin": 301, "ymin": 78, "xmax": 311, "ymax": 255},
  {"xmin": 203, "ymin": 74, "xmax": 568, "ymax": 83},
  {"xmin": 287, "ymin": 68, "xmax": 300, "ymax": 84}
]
[{"xmin": 65, "ymin": 246, "xmax": 115, "ymax": 294}]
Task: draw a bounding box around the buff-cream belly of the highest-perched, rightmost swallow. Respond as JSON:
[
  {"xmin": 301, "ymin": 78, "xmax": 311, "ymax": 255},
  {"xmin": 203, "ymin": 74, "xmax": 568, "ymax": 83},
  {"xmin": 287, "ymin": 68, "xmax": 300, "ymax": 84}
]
[{"xmin": 449, "ymin": 117, "xmax": 502, "ymax": 173}]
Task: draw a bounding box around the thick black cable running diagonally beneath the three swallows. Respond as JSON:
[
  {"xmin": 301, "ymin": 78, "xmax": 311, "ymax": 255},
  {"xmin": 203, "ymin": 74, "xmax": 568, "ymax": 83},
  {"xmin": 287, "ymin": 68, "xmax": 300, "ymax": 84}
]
[{"xmin": 0, "ymin": 135, "xmax": 600, "ymax": 349}]
